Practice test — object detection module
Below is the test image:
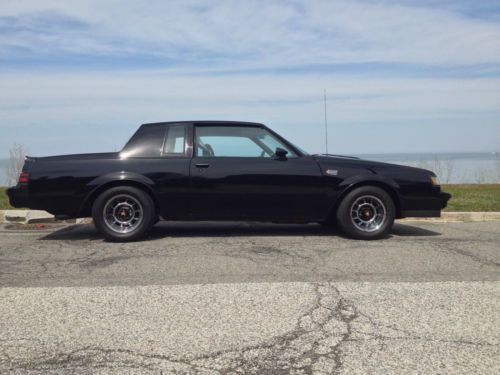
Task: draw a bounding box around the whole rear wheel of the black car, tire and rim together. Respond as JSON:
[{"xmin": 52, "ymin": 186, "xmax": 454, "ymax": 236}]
[{"xmin": 92, "ymin": 186, "xmax": 157, "ymax": 242}]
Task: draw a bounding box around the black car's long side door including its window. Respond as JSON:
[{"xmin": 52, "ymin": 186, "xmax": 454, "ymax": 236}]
[{"xmin": 190, "ymin": 124, "xmax": 326, "ymax": 222}]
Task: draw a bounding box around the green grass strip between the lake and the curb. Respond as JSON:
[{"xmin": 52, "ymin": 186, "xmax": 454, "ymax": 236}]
[{"xmin": 0, "ymin": 184, "xmax": 500, "ymax": 211}]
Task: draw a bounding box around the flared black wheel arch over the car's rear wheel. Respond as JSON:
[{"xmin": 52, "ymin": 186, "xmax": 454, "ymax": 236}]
[{"xmin": 79, "ymin": 175, "xmax": 159, "ymax": 217}]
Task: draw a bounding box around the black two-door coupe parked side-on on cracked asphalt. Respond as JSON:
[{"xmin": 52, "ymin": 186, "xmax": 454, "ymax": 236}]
[{"xmin": 7, "ymin": 121, "xmax": 450, "ymax": 241}]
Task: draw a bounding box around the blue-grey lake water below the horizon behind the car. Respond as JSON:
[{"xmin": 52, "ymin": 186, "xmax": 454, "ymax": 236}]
[{"xmin": 0, "ymin": 152, "xmax": 500, "ymax": 185}]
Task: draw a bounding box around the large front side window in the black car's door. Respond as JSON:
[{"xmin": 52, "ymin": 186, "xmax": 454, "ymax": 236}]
[{"xmin": 195, "ymin": 126, "xmax": 297, "ymax": 158}]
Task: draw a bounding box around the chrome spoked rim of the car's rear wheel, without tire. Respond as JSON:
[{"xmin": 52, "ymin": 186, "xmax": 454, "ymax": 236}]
[{"xmin": 103, "ymin": 194, "xmax": 144, "ymax": 233}]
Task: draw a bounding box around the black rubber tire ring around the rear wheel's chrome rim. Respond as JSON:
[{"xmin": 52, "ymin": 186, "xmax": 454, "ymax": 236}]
[{"xmin": 92, "ymin": 186, "xmax": 156, "ymax": 242}]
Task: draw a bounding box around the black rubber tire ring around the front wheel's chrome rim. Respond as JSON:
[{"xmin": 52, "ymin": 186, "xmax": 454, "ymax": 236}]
[{"xmin": 336, "ymin": 186, "xmax": 396, "ymax": 240}]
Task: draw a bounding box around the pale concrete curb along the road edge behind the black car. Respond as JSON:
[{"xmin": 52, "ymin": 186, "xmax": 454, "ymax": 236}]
[{"xmin": 0, "ymin": 210, "xmax": 500, "ymax": 224}]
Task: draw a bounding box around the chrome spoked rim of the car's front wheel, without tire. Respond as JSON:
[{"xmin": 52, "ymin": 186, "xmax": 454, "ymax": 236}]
[{"xmin": 351, "ymin": 195, "xmax": 387, "ymax": 232}]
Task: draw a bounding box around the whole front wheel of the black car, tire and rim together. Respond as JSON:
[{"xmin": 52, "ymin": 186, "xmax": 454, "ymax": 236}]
[{"xmin": 336, "ymin": 186, "xmax": 396, "ymax": 240}]
